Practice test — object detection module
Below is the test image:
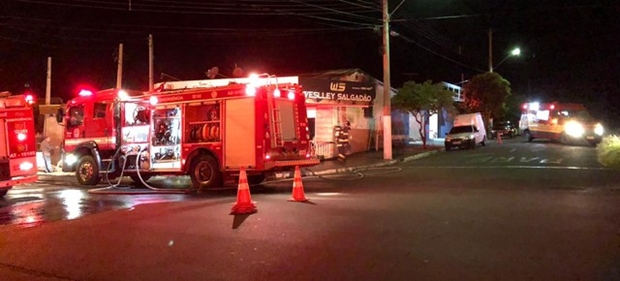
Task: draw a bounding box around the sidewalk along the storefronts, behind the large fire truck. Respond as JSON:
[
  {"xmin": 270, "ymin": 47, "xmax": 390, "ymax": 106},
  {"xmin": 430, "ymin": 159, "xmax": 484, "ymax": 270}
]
[{"xmin": 37, "ymin": 139, "xmax": 444, "ymax": 181}]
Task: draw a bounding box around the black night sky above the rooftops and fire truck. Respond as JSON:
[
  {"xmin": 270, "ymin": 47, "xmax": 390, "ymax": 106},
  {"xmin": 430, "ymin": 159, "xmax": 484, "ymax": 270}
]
[{"xmin": 0, "ymin": 0, "xmax": 620, "ymax": 125}]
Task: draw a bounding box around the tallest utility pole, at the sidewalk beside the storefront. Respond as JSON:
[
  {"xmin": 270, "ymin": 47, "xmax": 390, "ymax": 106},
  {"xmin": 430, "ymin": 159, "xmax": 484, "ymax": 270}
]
[{"xmin": 383, "ymin": 0, "xmax": 390, "ymax": 160}]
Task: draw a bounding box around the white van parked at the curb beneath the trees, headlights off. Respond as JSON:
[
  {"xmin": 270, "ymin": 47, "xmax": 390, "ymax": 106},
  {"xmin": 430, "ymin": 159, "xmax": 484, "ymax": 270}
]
[{"xmin": 444, "ymin": 112, "xmax": 487, "ymax": 151}]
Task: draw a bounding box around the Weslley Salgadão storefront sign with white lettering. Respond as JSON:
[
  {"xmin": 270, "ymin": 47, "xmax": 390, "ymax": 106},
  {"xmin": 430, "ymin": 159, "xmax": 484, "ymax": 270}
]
[{"xmin": 299, "ymin": 77, "xmax": 375, "ymax": 105}]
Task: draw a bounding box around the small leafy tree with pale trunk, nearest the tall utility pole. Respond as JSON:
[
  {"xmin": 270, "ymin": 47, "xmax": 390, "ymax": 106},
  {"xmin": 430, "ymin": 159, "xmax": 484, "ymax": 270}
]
[{"xmin": 391, "ymin": 80, "xmax": 455, "ymax": 149}]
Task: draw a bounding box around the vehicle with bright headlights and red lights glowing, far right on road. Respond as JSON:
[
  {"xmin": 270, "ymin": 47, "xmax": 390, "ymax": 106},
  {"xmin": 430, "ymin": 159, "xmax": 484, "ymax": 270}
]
[{"xmin": 519, "ymin": 102, "xmax": 605, "ymax": 145}]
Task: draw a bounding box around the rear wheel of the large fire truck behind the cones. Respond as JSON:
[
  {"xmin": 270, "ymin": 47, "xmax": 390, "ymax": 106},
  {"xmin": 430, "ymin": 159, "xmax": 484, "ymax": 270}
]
[{"xmin": 190, "ymin": 155, "xmax": 222, "ymax": 189}]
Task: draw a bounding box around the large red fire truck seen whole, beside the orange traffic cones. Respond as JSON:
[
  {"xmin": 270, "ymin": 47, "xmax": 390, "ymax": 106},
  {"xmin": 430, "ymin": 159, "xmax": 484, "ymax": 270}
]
[{"xmin": 58, "ymin": 76, "xmax": 319, "ymax": 189}]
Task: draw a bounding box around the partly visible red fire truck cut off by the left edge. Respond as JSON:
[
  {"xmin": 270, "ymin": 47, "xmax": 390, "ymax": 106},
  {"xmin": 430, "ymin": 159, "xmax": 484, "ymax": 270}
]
[{"xmin": 0, "ymin": 92, "xmax": 38, "ymax": 197}]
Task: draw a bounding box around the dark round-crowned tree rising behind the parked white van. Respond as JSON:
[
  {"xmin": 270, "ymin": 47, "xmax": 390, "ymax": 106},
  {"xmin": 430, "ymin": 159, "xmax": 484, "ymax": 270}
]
[{"xmin": 462, "ymin": 72, "xmax": 510, "ymax": 133}]
